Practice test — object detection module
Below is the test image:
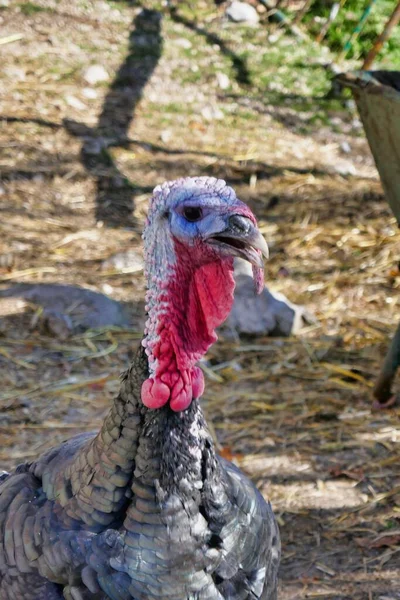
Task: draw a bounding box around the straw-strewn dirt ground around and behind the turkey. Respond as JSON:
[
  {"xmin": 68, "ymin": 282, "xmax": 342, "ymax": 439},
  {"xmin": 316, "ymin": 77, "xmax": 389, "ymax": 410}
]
[{"xmin": 0, "ymin": 0, "xmax": 400, "ymax": 600}]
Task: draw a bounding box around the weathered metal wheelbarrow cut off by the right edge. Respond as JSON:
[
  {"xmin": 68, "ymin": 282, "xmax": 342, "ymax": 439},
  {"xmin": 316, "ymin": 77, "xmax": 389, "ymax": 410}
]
[{"xmin": 337, "ymin": 71, "xmax": 400, "ymax": 407}]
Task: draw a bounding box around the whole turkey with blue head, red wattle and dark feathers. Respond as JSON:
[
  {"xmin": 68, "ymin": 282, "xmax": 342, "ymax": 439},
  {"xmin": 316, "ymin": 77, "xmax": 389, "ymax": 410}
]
[{"xmin": 0, "ymin": 177, "xmax": 280, "ymax": 600}]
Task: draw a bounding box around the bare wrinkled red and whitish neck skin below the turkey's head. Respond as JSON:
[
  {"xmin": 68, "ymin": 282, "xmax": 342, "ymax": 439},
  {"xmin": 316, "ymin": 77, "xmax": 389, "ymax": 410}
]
[{"xmin": 141, "ymin": 240, "xmax": 235, "ymax": 411}]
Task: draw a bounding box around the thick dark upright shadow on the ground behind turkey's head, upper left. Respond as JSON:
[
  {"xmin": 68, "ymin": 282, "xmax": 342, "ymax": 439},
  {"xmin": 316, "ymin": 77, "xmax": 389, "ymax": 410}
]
[{"xmin": 64, "ymin": 9, "xmax": 163, "ymax": 227}]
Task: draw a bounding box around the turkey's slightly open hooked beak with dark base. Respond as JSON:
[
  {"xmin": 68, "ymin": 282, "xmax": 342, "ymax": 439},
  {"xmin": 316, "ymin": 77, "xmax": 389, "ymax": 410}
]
[{"xmin": 207, "ymin": 215, "xmax": 269, "ymax": 269}]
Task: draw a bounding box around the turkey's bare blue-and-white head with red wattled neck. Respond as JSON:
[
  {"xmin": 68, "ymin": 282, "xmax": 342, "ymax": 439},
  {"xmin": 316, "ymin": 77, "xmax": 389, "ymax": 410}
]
[{"xmin": 141, "ymin": 177, "xmax": 268, "ymax": 411}]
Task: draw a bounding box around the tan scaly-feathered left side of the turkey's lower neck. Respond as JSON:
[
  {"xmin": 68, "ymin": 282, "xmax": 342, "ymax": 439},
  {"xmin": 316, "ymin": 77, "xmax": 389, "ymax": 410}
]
[{"xmin": 43, "ymin": 347, "xmax": 148, "ymax": 531}]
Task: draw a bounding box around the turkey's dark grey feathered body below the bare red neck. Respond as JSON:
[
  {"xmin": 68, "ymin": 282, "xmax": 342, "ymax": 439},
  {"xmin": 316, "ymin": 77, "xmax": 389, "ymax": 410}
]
[{"xmin": 0, "ymin": 178, "xmax": 280, "ymax": 600}]
